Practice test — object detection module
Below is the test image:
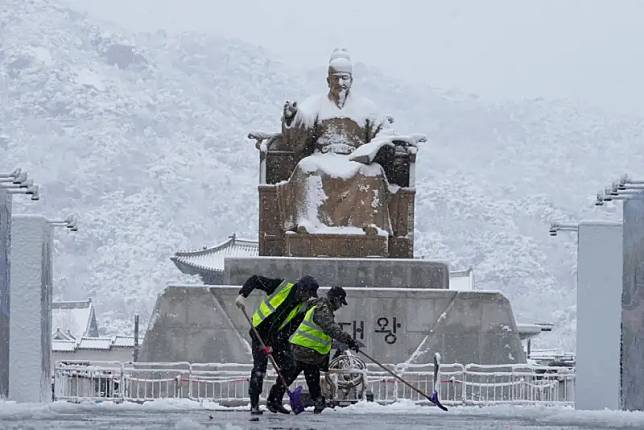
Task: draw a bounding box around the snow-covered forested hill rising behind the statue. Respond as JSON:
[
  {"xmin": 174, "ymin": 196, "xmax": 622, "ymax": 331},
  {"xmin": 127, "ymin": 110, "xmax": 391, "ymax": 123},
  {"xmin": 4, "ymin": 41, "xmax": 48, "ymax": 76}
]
[{"xmin": 0, "ymin": 0, "xmax": 644, "ymax": 349}]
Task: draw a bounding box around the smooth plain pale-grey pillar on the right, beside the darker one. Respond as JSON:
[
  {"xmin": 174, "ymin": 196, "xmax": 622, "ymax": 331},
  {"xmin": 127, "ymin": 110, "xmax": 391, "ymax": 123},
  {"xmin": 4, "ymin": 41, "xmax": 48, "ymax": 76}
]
[{"xmin": 575, "ymin": 222, "xmax": 622, "ymax": 410}]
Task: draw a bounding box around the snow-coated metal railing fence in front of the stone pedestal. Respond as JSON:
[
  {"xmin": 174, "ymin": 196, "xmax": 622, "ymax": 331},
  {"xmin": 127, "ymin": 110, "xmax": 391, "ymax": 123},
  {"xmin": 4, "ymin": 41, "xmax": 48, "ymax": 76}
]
[{"xmin": 53, "ymin": 361, "xmax": 575, "ymax": 405}]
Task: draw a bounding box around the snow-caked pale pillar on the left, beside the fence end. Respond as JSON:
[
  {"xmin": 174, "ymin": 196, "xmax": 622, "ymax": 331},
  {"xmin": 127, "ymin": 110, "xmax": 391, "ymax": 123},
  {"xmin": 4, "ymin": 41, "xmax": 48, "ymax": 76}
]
[{"xmin": 9, "ymin": 215, "xmax": 52, "ymax": 402}]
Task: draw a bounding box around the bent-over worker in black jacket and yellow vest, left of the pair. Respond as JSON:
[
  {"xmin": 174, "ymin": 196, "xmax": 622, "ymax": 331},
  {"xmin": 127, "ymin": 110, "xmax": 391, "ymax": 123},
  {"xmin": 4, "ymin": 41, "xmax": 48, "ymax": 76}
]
[{"xmin": 235, "ymin": 275, "xmax": 319, "ymax": 415}]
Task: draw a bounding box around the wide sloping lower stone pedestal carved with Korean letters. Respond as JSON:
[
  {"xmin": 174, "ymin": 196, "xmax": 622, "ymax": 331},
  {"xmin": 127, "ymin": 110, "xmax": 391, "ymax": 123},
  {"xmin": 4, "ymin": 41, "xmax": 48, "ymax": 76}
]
[{"xmin": 140, "ymin": 285, "xmax": 525, "ymax": 364}]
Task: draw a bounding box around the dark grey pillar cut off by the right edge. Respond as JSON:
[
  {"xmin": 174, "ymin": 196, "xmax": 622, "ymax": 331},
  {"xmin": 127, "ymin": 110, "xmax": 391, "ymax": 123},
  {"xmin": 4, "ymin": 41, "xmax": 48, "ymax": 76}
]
[{"xmin": 621, "ymin": 198, "xmax": 644, "ymax": 411}]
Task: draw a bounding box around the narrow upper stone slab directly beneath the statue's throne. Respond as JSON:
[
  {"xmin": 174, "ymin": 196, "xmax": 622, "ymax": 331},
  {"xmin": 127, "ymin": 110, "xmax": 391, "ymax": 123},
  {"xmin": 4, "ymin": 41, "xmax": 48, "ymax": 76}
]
[{"xmin": 224, "ymin": 257, "xmax": 449, "ymax": 289}]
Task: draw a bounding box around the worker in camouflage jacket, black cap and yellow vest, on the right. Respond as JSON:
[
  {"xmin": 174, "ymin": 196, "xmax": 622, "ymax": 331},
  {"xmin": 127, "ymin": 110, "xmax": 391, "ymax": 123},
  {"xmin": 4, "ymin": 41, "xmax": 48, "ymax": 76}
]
[{"xmin": 269, "ymin": 286, "xmax": 364, "ymax": 414}]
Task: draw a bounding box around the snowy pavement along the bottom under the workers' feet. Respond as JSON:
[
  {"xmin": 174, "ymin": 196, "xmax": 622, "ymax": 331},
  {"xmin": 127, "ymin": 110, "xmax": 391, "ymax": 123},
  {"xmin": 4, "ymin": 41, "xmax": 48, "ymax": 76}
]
[{"xmin": 0, "ymin": 400, "xmax": 644, "ymax": 430}]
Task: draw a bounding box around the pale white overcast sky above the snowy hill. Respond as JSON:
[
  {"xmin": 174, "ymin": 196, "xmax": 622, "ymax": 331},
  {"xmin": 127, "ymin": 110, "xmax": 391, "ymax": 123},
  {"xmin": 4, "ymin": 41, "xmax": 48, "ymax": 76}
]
[{"xmin": 62, "ymin": 0, "xmax": 644, "ymax": 115}]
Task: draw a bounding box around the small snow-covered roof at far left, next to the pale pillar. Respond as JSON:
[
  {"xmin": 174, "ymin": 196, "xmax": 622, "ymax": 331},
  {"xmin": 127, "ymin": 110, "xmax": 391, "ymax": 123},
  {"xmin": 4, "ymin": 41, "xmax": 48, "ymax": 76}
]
[{"xmin": 51, "ymin": 299, "xmax": 98, "ymax": 339}]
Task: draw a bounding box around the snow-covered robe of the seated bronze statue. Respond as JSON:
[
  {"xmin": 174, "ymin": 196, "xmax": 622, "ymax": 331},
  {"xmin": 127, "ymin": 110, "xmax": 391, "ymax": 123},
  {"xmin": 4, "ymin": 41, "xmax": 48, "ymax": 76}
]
[{"xmin": 277, "ymin": 94, "xmax": 393, "ymax": 236}]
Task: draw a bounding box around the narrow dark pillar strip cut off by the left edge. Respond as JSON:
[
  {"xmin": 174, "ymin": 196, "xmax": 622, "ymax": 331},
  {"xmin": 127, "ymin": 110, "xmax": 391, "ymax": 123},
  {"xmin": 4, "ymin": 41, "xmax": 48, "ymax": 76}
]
[{"xmin": 0, "ymin": 188, "xmax": 11, "ymax": 399}]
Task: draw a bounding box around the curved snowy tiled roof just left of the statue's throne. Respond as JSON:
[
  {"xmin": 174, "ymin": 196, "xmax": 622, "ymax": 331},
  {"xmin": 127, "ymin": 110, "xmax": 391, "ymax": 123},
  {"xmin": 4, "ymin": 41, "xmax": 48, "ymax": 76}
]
[{"xmin": 170, "ymin": 234, "xmax": 259, "ymax": 283}]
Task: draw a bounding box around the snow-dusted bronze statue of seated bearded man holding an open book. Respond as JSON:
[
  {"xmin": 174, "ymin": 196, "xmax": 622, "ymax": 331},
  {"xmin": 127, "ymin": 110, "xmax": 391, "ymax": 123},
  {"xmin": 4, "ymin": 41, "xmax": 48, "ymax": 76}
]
[{"xmin": 254, "ymin": 49, "xmax": 424, "ymax": 256}]
